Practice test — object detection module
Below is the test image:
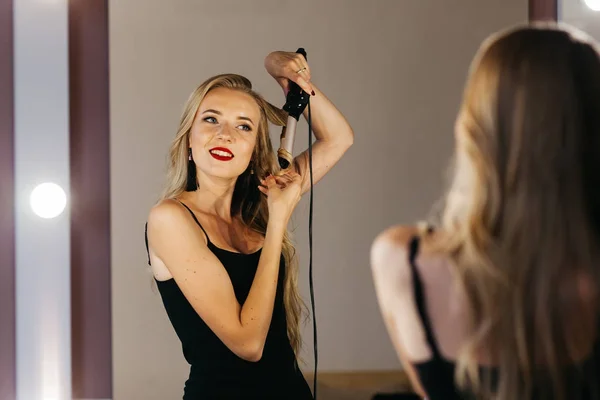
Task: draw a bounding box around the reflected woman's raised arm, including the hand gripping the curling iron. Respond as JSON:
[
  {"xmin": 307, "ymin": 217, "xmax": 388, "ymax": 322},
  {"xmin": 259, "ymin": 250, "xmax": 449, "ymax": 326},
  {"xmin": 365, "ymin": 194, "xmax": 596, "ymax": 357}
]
[{"xmin": 265, "ymin": 51, "xmax": 354, "ymax": 194}]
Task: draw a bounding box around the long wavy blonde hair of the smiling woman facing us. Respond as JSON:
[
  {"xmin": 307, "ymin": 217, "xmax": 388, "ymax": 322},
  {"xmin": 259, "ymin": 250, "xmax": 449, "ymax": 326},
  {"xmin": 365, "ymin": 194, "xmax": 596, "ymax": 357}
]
[{"xmin": 160, "ymin": 74, "xmax": 306, "ymax": 355}]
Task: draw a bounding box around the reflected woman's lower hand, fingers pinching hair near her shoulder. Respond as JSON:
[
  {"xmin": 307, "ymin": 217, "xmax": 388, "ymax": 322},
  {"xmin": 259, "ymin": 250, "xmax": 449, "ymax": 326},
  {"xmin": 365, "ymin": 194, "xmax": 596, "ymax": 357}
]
[{"xmin": 258, "ymin": 171, "xmax": 302, "ymax": 224}]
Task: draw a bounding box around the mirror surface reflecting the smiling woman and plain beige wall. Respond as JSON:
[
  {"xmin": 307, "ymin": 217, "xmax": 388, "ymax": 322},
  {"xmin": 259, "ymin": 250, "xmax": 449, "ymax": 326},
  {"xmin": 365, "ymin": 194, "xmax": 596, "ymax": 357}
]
[{"xmin": 109, "ymin": 0, "xmax": 527, "ymax": 400}]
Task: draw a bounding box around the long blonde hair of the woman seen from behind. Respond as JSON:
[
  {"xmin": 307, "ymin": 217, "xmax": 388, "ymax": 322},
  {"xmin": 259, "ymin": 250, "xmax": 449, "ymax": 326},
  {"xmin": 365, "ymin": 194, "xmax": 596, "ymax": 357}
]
[{"xmin": 443, "ymin": 24, "xmax": 600, "ymax": 399}]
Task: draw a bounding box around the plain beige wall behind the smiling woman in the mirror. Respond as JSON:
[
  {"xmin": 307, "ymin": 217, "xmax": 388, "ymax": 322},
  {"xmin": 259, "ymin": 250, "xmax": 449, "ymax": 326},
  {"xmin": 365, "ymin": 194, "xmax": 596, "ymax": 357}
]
[{"xmin": 110, "ymin": 0, "xmax": 527, "ymax": 400}]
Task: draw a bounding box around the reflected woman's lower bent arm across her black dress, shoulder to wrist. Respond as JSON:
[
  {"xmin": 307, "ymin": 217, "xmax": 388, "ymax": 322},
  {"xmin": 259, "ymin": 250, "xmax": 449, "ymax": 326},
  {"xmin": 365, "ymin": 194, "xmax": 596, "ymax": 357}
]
[{"xmin": 148, "ymin": 201, "xmax": 287, "ymax": 361}]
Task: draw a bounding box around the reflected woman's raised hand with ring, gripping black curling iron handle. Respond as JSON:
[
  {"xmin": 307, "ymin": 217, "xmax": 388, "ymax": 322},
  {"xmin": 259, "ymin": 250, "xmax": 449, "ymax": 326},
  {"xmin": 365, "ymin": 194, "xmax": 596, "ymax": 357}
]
[{"xmin": 265, "ymin": 51, "xmax": 315, "ymax": 96}]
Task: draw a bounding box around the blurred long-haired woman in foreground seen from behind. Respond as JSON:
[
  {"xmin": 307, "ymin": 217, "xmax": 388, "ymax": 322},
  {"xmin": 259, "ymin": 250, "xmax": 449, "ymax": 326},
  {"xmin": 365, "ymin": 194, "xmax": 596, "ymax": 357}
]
[{"xmin": 371, "ymin": 25, "xmax": 600, "ymax": 400}]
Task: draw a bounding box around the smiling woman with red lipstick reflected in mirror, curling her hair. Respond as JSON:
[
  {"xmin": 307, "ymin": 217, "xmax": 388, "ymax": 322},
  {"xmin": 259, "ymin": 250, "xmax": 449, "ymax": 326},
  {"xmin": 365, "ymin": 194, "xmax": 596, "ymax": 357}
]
[{"xmin": 147, "ymin": 51, "xmax": 354, "ymax": 400}]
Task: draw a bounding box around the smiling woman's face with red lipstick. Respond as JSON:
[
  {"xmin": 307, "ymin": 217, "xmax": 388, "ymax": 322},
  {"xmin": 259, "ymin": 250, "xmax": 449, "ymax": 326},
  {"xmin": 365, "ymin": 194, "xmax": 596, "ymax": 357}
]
[{"xmin": 190, "ymin": 88, "xmax": 260, "ymax": 179}]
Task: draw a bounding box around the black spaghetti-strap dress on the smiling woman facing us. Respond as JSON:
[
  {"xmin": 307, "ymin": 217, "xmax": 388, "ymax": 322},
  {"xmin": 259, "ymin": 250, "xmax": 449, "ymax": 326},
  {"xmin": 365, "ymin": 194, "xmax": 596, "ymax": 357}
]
[{"xmin": 146, "ymin": 203, "xmax": 313, "ymax": 400}]
